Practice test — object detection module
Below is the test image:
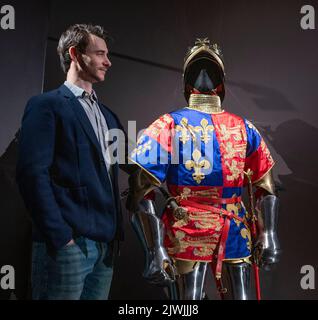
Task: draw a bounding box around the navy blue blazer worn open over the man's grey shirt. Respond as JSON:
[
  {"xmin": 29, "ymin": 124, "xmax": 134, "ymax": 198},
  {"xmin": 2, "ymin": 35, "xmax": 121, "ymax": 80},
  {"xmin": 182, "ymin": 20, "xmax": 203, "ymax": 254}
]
[{"xmin": 16, "ymin": 85, "xmax": 123, "ymax": 249}]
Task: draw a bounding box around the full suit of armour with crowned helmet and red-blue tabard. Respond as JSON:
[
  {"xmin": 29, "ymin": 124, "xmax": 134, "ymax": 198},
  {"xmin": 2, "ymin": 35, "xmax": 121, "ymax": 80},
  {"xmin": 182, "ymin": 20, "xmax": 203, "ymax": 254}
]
[{"xmin": 127, "ymin": 39, "xmax": 280, "ymax": 299}]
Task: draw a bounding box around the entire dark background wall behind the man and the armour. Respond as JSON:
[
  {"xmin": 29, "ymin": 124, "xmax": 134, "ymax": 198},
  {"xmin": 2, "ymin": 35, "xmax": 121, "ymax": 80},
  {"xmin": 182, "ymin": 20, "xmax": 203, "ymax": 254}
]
[{"xmin": 0, "ymin": 0, "xmax": 318, "ymax": 299}]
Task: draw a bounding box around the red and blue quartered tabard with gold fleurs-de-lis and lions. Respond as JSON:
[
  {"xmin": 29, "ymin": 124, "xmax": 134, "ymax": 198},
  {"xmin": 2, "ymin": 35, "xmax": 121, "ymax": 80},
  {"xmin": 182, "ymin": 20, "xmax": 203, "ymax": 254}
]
[{"xmin": 131, "ymin": 107, "xmax": 274, "ymax": 262}]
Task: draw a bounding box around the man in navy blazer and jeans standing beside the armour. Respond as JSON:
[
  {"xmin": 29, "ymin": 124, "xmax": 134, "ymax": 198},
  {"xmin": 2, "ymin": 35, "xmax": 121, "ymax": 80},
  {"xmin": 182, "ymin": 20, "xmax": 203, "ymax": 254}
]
[{"xmin": 17, "ymin": 24, "xmax": 122, "ymax": 299}]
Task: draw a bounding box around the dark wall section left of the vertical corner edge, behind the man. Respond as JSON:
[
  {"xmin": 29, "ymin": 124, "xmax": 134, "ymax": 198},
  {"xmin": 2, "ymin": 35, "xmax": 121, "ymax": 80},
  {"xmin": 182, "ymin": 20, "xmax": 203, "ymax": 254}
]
[{"xmin": 0, "ymin": 1, "xmax": 49, "ymax": 299}]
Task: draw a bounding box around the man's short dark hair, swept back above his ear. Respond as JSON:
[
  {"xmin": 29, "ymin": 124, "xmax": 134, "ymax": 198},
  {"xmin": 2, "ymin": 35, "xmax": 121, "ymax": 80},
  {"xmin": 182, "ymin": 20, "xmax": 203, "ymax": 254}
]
[{"xmin": 57, "ymin": 24, "xmax": 108, "ymax": 73}]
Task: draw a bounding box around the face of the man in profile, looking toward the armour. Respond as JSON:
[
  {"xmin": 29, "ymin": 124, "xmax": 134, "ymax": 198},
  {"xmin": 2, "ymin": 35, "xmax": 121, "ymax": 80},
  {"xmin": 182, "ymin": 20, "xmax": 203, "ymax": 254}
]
[{"xmin": 78, "ymin": 34, "xmax": 111, "ymax": 83}]
